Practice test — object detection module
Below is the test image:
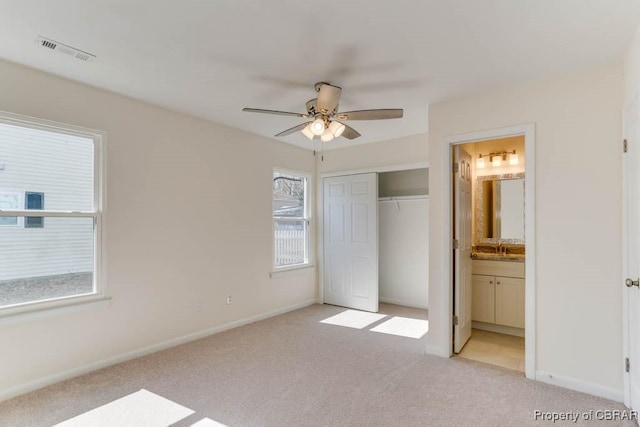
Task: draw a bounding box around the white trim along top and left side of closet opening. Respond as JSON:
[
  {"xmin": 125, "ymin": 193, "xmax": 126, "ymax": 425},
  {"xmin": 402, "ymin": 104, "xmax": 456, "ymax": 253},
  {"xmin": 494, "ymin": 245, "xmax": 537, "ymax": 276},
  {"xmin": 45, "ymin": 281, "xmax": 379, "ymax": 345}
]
[{"xmin": 316, "ymin": 162, "xmax": 429, "ymax": 304}]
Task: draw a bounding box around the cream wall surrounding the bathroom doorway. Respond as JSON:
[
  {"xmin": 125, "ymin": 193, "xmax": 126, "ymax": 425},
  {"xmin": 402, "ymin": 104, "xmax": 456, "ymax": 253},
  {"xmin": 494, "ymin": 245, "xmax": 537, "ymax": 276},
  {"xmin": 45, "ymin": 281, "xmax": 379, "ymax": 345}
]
[{"xmin": 427, "ymin": 64, "xmax": 623, "ymax": 400}]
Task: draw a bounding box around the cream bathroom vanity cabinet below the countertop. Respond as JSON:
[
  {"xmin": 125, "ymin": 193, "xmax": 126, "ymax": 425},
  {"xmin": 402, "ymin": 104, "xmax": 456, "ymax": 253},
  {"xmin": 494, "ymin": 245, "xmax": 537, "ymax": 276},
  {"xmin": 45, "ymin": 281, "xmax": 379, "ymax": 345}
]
[{"xmin": 471, "ymin": 259, "xmax": 524, "ymax": 335}]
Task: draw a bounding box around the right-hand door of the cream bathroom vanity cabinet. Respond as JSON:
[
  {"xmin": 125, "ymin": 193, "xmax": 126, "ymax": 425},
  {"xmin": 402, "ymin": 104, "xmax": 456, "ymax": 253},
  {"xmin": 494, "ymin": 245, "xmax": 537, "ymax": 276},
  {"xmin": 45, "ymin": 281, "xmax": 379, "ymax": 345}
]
[{"xmin": 495, "ymin": 276, "xmax": 524, "ymax": 328}]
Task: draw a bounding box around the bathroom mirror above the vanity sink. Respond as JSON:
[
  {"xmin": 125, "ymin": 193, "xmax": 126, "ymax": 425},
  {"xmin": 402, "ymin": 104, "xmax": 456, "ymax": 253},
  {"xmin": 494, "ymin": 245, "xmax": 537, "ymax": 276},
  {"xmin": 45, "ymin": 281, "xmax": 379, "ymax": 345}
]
[{"xmin": 475, "ymin": 173, "xmax": 524, "ymax": 244}]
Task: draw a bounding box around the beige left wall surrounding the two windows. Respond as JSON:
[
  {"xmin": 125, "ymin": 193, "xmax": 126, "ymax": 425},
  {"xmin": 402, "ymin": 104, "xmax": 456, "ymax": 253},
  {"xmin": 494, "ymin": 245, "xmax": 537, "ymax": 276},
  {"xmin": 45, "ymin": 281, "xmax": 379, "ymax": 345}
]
[{"xmin": 0, "ymin": 62, "xmax": 316, "ymax": 399}]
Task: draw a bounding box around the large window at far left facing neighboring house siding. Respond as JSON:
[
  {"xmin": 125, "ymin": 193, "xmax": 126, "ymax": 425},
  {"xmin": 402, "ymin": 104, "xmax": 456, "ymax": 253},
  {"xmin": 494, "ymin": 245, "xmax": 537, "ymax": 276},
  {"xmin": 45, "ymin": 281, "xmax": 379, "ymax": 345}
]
[{"xmin": 0, "ymin": 113, "xmax": 104, "ymax": 315}]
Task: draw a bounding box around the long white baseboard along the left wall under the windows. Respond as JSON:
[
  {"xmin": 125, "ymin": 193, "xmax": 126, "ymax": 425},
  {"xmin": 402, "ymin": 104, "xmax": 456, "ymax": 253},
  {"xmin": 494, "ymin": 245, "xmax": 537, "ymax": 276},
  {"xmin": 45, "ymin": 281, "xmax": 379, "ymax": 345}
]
[{"xmin": 0, "ymin": 299, "xmax": 317, "ymax": 402}]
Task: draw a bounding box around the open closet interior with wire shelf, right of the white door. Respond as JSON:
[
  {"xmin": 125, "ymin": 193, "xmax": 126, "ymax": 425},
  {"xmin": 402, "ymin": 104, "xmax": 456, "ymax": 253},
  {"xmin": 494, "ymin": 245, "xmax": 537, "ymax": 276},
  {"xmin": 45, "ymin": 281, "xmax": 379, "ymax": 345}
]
[{"xmin": 378, "ymin": 168, "xmax": 429, "ymax": 309}]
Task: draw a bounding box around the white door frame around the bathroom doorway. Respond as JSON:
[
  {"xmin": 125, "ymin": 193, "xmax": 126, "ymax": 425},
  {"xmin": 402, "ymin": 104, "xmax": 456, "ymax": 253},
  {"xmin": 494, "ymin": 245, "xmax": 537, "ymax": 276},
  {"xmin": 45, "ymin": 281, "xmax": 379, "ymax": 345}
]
[{"xmin": 444, "ymin": 123, "xmax": 536, "ymax": 379}]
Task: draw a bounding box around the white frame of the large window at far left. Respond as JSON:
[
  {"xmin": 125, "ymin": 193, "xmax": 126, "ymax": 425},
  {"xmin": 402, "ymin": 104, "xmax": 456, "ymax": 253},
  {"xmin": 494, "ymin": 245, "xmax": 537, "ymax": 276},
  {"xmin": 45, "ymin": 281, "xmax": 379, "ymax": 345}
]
[{"xmin": 0, "ymin": 111, "xmax": 109, "ymax": 319}]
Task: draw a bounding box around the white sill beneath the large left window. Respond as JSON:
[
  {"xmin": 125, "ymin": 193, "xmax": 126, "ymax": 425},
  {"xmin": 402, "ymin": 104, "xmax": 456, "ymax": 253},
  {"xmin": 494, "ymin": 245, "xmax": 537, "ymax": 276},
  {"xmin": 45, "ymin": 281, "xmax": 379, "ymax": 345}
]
[{"xmin": 0, "ymin": 295, "xmax": 111, "ymax": 326}]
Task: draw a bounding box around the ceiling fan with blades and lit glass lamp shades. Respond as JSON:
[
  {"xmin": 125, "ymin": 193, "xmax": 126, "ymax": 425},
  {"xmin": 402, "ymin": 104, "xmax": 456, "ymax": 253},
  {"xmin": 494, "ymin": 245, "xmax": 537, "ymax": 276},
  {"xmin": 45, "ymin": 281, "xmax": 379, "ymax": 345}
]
[{"xmin": 242, "ymin": 82, "xmax": 403, "ymax": 142}]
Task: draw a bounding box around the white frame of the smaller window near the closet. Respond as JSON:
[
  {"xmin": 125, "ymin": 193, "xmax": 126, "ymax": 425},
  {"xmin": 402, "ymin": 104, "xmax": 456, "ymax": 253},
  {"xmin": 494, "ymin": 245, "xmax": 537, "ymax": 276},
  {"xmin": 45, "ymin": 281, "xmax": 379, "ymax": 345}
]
[{"xmin": 271, "ymin": 168, "xmax": 313, "ymax": 272}]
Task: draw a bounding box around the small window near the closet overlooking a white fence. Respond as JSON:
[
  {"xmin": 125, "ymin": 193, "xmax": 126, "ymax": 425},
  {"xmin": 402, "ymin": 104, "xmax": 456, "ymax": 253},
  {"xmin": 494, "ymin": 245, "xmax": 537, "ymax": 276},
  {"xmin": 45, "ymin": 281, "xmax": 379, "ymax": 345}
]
[{"xmin": 273, "ymin": 170, "xmax": 310, "ymax": 269}]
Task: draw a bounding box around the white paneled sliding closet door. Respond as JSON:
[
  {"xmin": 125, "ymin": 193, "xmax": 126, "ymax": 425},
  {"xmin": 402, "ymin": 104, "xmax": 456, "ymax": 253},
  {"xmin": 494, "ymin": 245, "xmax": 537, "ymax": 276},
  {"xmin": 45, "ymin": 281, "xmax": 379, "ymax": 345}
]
[{"xmin": 323, "ymin": 173, "xmax": 378, "ymax": 312}]
